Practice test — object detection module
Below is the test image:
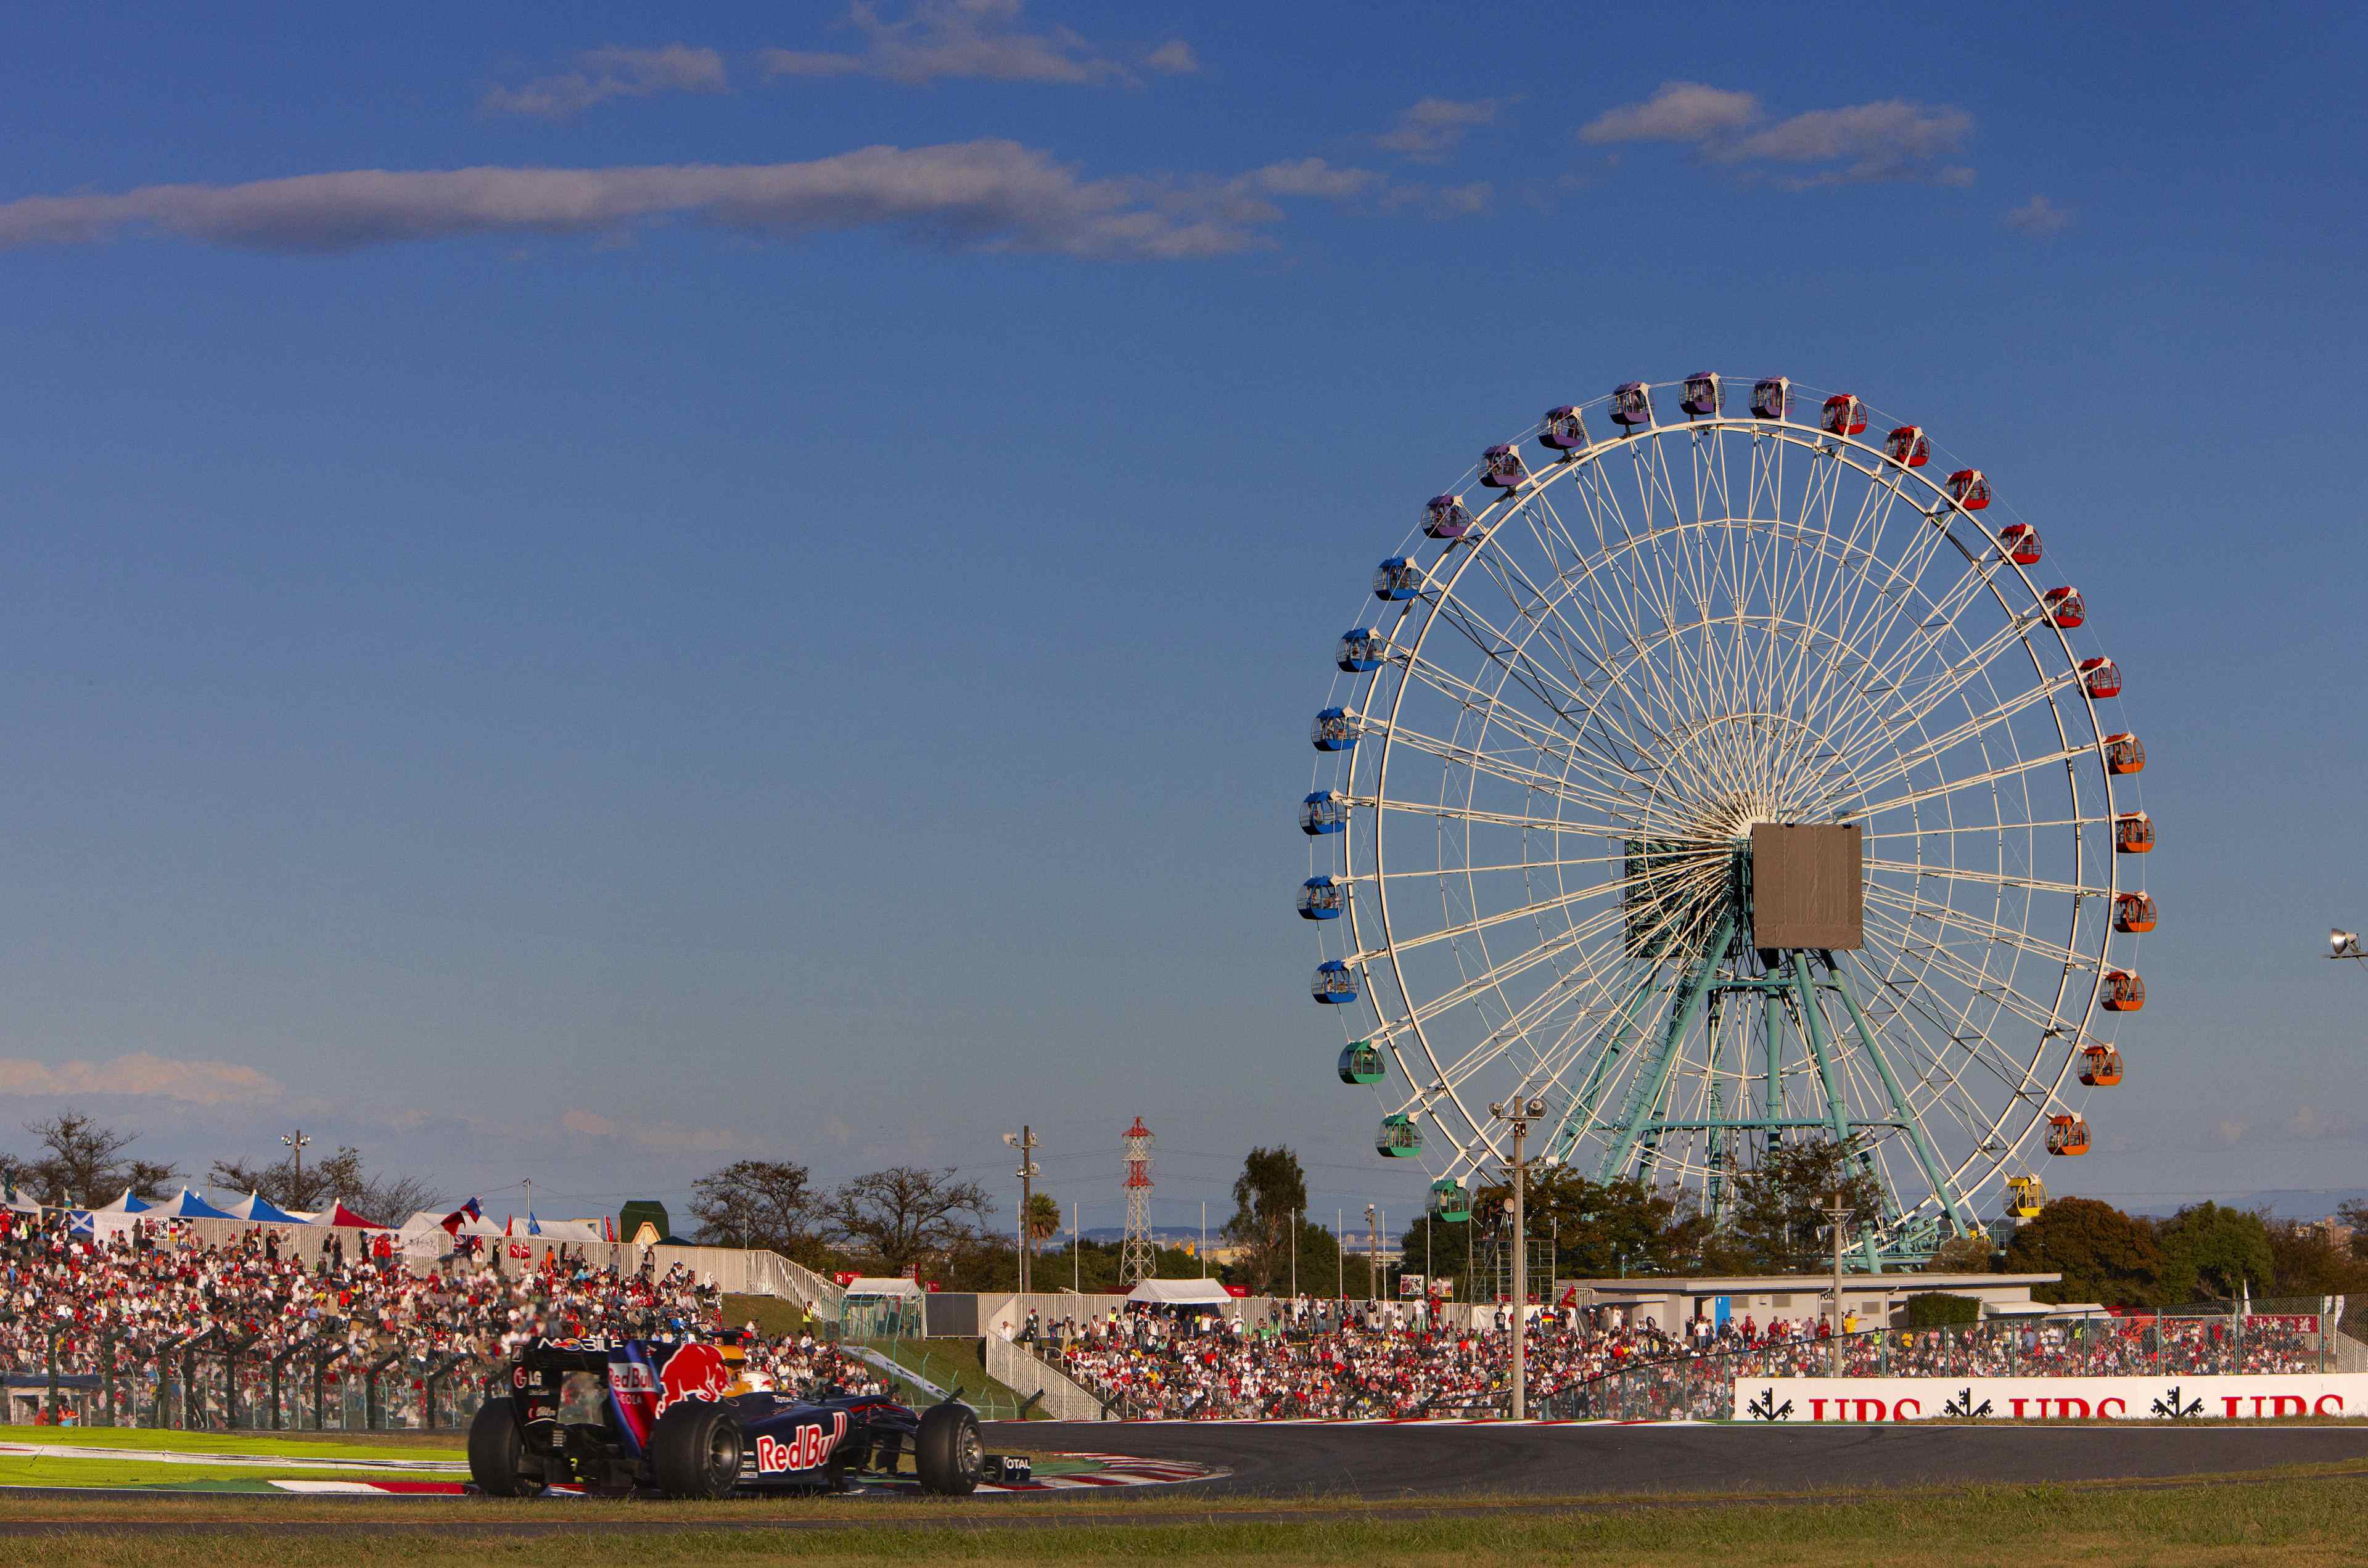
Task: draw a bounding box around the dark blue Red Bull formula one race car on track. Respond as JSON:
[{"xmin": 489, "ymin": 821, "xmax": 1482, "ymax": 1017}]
[{"xmin": 469, "ymin": 1334, "xmax": 1028, "ymax": 1497}]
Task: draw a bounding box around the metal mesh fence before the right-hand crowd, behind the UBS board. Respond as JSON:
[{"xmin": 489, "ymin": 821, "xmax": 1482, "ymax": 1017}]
[{"xmin": 1534, "ymin": 1307, "xmax": 2342, "ymax": 1421}]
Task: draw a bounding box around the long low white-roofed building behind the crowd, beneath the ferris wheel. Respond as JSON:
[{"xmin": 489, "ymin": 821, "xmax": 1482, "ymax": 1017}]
[{"xmin": 1553, "ymin": 1275, "xmax": 2063, "ymax": 1334}]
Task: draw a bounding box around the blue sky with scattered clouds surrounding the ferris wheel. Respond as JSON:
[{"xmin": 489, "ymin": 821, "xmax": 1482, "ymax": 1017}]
[{"xmin": 0, "ymin": 0, "xmax": 2368, "ymax": 1225}]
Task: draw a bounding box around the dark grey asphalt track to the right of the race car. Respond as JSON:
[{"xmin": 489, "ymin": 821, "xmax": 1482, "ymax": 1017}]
[{"xmin": 987, "ymin": 1421, "xmax": 2368, "ymax": 1500}]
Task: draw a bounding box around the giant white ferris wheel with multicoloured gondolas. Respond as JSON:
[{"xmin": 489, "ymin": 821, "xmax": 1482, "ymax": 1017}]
[{"xmin": 1297, "ymin": 374, "xmax": 2155, "ymax": 1262}]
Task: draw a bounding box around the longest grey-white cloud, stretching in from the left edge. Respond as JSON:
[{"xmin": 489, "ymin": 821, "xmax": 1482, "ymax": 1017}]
[{"xmin": 0, "ymin": 140, "xmax": 1317, "ymax": 261}]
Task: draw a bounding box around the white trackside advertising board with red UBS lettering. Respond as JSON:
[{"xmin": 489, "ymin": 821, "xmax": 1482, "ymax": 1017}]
[{"xmin": 1736, "ymin": 1371, "xmax": 2368, "ymax": 1426}]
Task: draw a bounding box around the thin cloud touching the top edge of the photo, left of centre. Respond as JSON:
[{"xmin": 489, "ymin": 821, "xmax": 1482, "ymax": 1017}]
[{"xmin": 758, "ymin": 0, "xmax": 1155, "ymax": 85}]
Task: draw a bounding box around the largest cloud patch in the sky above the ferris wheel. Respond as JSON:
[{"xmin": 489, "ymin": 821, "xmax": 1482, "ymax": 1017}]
[{"xmin": 1579, "ymin": 81, "xmax": 1973, "ymax": 189}]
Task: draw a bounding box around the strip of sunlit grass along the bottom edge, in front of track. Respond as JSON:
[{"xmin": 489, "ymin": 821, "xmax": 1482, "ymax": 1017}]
[{"xmin": 0, "ymin": 1466, "xmax": 2368, "ymax": 1568}]
